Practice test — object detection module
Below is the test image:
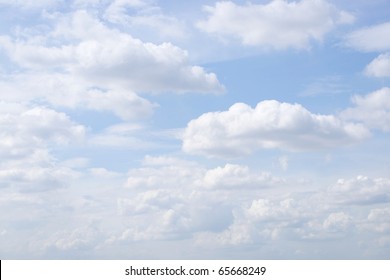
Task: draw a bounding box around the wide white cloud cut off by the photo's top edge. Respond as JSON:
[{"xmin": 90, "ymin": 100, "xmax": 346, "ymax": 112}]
[{"xmin": 197, "ymin": 0, "xmax": 353, "ymax": 49}]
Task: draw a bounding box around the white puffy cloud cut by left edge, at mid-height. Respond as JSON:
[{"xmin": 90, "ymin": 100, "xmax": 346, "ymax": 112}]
[{"xmin": 0, "ymin": 103, "xmax": 86, "ymax": 192}]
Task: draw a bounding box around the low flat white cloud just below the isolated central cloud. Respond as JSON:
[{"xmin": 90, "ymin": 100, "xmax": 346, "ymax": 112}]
[{"xmin": 127, "ymin": 156, "xmax": 283, "ymax": 190}]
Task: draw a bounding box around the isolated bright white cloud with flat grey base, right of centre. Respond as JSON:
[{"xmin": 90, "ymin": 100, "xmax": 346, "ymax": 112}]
[{"xmin": 182, "ymin": 100, "xmax": 369, "ymax": 156}]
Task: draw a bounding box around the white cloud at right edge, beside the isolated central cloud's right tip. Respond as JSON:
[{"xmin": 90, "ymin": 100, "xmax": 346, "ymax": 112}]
[{"xmin": 340, "ymin": 87, "xmax": 390, "ymax": 131}]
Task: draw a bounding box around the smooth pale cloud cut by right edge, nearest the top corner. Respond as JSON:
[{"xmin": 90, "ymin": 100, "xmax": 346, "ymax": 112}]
[{"xmin": 345, "ymin": 22, "xmax": 390, "ymax": 52}]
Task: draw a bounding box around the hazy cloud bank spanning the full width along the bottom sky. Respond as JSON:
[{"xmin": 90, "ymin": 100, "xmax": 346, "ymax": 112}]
[{"xmin": 0, "ymin": 151, "xmax": 389, "ymax": 258}]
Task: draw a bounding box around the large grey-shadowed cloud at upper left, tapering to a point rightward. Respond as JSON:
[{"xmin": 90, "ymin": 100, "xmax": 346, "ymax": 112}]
[{"xmin": 0, "ymin": 11, "xmax": 222, "ymax": 92}]
